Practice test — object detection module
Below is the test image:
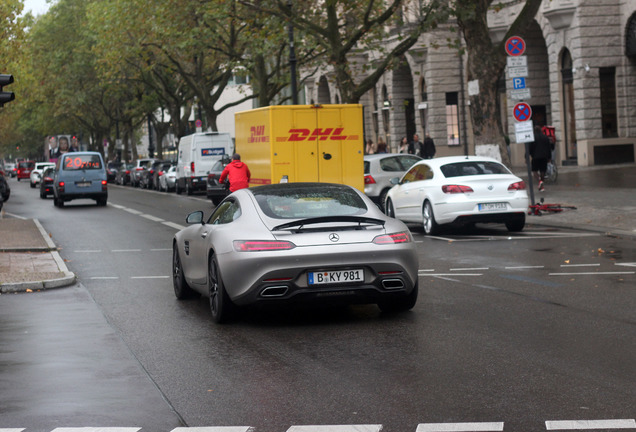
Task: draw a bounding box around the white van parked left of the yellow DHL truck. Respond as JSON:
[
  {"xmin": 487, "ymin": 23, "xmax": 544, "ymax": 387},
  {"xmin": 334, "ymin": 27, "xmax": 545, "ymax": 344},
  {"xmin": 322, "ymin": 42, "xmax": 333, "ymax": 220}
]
[{"xmin": 175, "ymin": 132, "xmax": 234, "ymax": 195}]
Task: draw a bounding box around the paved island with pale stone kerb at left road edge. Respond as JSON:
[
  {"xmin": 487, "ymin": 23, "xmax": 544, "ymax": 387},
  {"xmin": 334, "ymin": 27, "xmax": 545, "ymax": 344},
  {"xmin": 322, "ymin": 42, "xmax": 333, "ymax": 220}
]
[{"xmin": 0, "ymin": 218, "xmax": 76, "ymax": 294}]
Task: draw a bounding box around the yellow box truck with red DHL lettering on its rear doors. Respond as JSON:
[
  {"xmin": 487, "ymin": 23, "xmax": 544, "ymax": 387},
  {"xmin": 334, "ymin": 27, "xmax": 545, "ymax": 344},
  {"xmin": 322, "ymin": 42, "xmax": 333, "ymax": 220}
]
[{"xmin": 234, "ymin": 104, "xmax": 364, "ymax": 192}]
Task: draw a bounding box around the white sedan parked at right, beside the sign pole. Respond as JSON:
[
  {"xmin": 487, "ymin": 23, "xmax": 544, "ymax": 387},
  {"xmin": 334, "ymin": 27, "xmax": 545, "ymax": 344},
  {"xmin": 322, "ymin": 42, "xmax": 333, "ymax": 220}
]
[{"xmin": 385, "ymin": 156, "xmax": 530, "ymax": 235}]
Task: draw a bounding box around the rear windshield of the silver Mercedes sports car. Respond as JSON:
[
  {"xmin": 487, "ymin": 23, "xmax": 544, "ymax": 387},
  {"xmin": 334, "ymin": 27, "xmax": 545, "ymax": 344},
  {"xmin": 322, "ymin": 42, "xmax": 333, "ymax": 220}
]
[{"xmin": 253, "ymin": 183, "xmax": 367, "ymax": 219}]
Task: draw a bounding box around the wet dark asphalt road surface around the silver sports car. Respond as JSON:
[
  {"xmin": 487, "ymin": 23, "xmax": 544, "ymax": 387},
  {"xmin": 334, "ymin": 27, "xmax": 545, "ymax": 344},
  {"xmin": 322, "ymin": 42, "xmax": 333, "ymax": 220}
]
[{"xmin": 0, "ymin": 175, "xmax": 636, "ymax": 432}]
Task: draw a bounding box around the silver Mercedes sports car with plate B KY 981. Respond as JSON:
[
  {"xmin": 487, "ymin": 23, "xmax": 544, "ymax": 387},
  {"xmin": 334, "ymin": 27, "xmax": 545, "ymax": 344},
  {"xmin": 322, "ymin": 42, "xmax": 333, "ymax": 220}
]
[{"xmin": 172, "ymin": 183, "xmax": 418, "ymax": 322}]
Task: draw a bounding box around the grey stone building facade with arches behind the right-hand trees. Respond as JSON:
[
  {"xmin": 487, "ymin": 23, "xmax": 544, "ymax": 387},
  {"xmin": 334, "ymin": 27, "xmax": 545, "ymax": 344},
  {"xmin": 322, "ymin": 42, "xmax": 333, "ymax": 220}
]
[{"xmin": 305, "ymin": 0, "xmax": 636, "ymax": 166}]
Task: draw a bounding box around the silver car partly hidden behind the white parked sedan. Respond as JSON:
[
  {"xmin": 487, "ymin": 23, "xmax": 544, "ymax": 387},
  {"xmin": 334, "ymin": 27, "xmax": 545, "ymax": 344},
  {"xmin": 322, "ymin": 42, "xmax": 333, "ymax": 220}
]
[{"xmin": 364, "ymin": 153, "xmax": 422, "ymax": 209}]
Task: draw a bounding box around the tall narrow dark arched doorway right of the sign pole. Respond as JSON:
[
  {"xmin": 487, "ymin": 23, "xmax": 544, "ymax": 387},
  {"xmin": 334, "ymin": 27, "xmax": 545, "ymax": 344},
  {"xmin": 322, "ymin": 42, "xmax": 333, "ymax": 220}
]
[{"xmin": 560, "ymin": 49, "xmax": 577, "ymax": 165}]
